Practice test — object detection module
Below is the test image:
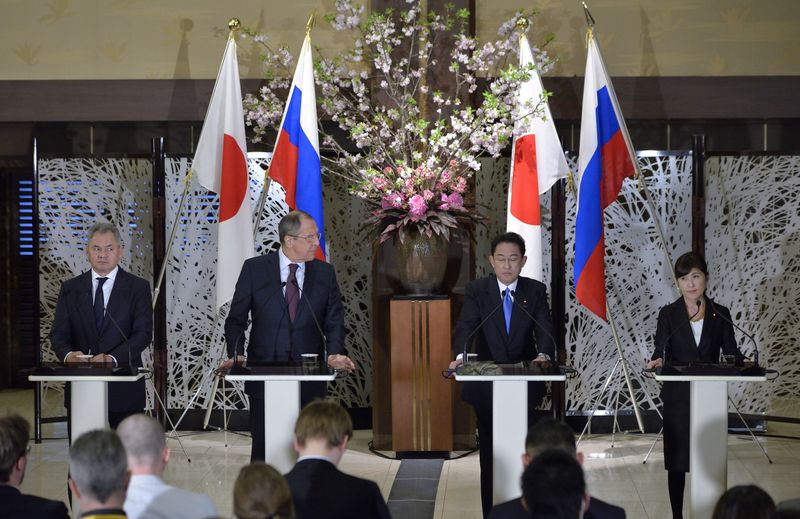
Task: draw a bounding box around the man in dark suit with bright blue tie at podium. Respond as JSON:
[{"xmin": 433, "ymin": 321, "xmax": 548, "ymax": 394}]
[{"xmin": 450, "ymin": 232, "xmax": 556, "ymax": 516}]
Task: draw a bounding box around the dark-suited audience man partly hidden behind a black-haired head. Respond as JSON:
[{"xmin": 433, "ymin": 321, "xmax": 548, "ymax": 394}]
[{"xmin": 489, "ymin": 418, "xmax": 625, "ymax": 519}]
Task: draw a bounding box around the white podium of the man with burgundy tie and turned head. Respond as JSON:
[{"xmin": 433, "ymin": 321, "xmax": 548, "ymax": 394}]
[{"xmin": 224, "ymin": 365, "xmax": 336, "ymax": 474}]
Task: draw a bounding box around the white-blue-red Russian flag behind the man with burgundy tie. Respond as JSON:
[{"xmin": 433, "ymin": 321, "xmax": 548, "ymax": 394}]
[{"xmin": 269, "ymin": 34, "xmax": 327, "ymax": 261}]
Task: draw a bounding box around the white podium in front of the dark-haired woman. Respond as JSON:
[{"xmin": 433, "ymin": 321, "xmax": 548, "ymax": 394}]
[{"xmin": 655, "ymin": 369, "xmax": 767, "ymax": 519}]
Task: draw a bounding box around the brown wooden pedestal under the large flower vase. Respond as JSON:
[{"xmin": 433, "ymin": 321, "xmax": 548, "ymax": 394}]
[{"xmin": 390, "ymin": 299, "xmax": 453, "ymax": 451}]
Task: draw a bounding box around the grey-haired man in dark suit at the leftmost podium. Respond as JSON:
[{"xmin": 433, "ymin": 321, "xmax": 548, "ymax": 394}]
[{"xmin": 50, "ymin": 222, "xmax": 153, "ymax": 428}]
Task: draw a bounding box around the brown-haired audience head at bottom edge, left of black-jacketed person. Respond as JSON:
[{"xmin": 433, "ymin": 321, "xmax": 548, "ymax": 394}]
[{"xmin": 233, "ymin": 462, "xmax": 294, "ymax": 519}]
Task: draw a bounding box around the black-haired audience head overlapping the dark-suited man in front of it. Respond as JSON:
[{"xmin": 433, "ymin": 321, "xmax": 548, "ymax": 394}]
[{"xmin": 522, "ymin": 449, "xmax": 589, "ymax": 519}]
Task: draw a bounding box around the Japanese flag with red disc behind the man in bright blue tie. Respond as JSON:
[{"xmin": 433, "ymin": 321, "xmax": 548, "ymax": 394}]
[{"xmin": 506, "ymin": 33, "xmax": 569, "ymax": 281}]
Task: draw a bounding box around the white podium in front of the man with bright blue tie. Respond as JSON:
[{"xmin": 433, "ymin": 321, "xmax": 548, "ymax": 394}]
[{"xmin": 456, "ymin": 365, "xmax": 566, "ymax": 504}]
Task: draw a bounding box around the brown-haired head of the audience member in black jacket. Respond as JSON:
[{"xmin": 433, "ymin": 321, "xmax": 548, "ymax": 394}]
[{"xmin": 294, "ymin": 400, "xmax": 353, "ymax": 464}]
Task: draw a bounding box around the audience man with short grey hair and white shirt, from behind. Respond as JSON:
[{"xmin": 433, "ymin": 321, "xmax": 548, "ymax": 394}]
[{"xmin": 117, "ymin": 414, "xmax": 217, "ymax": 519}]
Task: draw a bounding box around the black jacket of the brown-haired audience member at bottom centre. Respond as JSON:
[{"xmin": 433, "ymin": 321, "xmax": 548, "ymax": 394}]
[{"xmin": 286, "ymin": 459, "xmax": 391, "ymax": 519}]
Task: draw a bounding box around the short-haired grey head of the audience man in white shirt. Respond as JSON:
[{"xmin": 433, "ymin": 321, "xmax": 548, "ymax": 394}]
[{"xmin": 117, "ymin": 414, "xmax": 170, "ymax": 477}]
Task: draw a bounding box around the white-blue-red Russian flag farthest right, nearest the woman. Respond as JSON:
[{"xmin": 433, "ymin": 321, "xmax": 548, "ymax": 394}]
[{"xmin": 575, "ymin": 34, "xmax": 636, "ymax": 319}]
